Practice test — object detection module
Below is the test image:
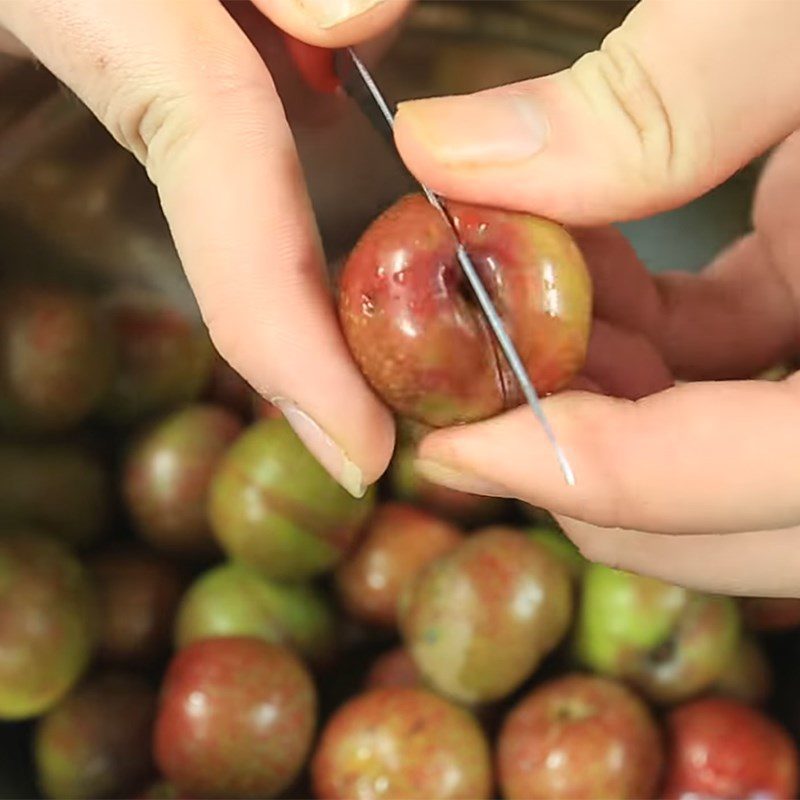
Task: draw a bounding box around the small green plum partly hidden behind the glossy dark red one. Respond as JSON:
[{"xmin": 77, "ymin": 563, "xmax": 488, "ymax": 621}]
[{"xmin": 175, "ymin": 563, "xmax": 336, "ymax": 663}]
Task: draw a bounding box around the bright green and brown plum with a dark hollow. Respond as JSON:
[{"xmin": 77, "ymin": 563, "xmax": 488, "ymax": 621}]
[{"xmin": 575, "ymin": 564, "xmax": 740, "ymax": 703}]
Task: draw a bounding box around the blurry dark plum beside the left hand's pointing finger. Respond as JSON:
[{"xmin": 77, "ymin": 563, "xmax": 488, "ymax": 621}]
[{"xmin": 102, "ymin": 294, "xmax": 214, "ymax": 425}]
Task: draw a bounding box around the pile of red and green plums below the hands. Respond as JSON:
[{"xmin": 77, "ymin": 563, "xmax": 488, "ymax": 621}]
[{"xmin": 0, "ymin": 195, "xmax": 800, "ymax": 800}]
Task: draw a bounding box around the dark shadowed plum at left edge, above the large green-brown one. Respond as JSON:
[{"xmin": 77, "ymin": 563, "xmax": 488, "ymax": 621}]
[{"xmin": 0, "ymin": 442, "xmax": 111, "ymax": 547}]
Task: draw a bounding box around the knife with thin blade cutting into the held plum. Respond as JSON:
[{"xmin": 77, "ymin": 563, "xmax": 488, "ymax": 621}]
[{"xmin": 334, "ymin": 47, "xmax": 575, "ymax": 486}]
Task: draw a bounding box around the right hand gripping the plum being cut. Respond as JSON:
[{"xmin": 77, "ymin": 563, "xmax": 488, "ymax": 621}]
[{"xmin": 396, "ymin": 0, "xmax": 800, "ymax": 596}]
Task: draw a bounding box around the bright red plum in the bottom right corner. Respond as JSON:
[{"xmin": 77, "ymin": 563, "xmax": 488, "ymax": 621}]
[{"xmin": 662, "ymin": 697, "xmax": 800, "ymax": 800}]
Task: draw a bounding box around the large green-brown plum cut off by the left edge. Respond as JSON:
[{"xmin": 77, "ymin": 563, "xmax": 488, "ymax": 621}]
[{"xmin": 0, "ymin": 532, "xmax": 97, "ymax": 720}]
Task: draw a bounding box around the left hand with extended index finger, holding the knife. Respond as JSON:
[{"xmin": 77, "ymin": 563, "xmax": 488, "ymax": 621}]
[{"xmin": 0, "ymin": 0, "xmax": 408, "ymax": 494}]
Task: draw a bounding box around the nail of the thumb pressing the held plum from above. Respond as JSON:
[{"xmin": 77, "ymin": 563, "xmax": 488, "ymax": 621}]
[{"xmin": 398, "ymin": 92, "xmax": 548, "ymax": 165}]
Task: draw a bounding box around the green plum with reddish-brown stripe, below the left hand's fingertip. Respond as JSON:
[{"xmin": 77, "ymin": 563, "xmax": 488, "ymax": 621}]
[{"xmin": 210, "ymin": 419, "xmax": 375, "ymax": 580}]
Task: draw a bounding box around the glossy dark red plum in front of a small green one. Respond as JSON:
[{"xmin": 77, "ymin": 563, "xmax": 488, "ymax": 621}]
[{"xmin": 154, "ymin": 637, "xmax": 316, "ymax": 798}]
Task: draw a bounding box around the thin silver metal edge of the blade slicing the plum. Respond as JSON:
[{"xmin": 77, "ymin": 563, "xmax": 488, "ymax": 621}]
[{"xmin": 340, "ymin": 47, "xmax": 575, "ymax": 486}]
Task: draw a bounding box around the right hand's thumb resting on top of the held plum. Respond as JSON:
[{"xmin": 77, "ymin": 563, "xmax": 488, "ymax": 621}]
[{"xmin": 395, "ymin": 0, "xmax": 800, "ymax": 224}]
